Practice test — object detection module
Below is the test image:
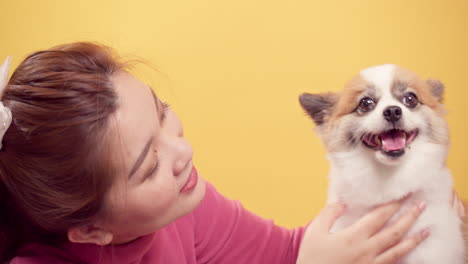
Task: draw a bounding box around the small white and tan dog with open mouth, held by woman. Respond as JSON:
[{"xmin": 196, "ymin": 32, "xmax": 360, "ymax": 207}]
[{"xmin": 299, "ymin": 65, "xmax": 464, "ymax": 264}]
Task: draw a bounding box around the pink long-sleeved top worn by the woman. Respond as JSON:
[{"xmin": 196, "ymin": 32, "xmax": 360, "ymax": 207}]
[{"xmin": 11, "ymin": 184, "xmax": 304, "ymax": 264}]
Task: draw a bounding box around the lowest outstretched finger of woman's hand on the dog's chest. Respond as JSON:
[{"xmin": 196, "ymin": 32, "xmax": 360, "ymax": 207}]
[{"xmin": 374, "ymin": 229, "xmax": 430, "ymax": 264}]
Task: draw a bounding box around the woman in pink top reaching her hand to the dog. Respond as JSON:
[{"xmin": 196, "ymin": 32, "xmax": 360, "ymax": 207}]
[{"xmin": 0, "ymin": 43, "xmax": 446, "ymax": 264}]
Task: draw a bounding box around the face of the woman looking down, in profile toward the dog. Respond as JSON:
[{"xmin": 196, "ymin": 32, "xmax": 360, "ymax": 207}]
[{"xmin": 103, "ymin": 71, "xmax": 205, "ymax": 244}]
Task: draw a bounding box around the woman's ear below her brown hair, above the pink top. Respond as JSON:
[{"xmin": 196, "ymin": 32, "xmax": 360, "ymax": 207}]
[{"xmin": 67, "ymin": 225, "xmax": 114, "ymax": 246}]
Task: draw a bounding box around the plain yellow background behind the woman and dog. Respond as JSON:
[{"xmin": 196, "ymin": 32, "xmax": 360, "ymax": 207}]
[{"xmin": 0, "ymin": 0, "xmax": 468, "ymax": 226}]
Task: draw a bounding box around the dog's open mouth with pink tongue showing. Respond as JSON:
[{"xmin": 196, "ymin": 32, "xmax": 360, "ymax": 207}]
[{"xmin": 362, "ymin": 129, "xmax": 418, "ymax": 157}]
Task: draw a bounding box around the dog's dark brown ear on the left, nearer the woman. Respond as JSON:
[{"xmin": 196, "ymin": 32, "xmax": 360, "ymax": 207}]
[{"xmin": 299, "ymin": 93, "xmax": 338, "ymax": 126}]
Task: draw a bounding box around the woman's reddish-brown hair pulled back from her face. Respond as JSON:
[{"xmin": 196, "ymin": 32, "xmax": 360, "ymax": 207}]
[{"xmin": 0, "ymin": 43, "xmax": 125, "ymax": 261}]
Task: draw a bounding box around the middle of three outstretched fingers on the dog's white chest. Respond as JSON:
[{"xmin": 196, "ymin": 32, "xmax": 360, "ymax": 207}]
[{"xmin": 370, "ymin": 202, "xmax": 426, "ymax": 252}]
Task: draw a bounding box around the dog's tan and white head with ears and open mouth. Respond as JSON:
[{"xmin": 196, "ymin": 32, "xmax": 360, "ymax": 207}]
[{"xmin": 299, "ymin": 64, "xmax": 448, "ymax": 165}]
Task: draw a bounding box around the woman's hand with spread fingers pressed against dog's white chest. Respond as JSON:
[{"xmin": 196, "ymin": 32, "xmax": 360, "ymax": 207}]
[{"xmin": 297, "ymin": 200, "xmax": 429, "ymax": 264}]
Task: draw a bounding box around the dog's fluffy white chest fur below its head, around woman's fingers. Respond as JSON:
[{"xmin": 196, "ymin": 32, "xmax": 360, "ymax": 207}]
[{"xmin": 328, "ymin": 142, "xmax": 463, "ymax": 264}]
